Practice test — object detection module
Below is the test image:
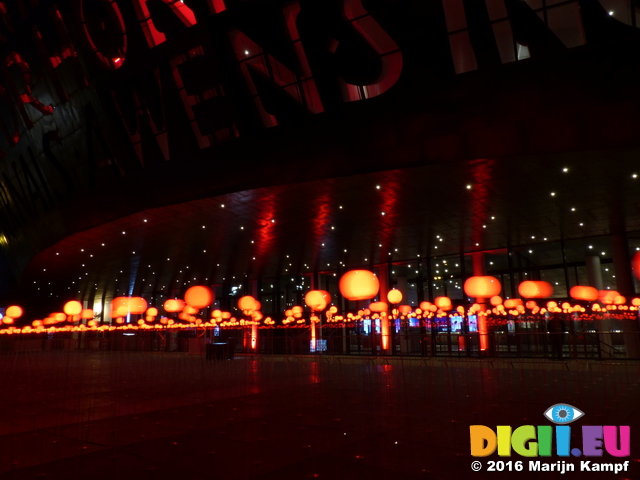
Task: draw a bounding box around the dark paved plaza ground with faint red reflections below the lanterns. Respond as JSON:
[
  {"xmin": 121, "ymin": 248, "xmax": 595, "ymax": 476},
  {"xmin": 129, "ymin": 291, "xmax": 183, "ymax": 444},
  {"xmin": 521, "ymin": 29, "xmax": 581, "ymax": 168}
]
[{"xmin": 0, "ymin": 352, "xmax": 640, "ymax": 480}]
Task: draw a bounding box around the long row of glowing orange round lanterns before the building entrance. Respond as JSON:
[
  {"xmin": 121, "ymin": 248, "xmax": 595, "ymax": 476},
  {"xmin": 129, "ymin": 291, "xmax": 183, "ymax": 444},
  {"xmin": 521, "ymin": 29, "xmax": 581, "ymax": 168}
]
[{"xmin": 2, "ymin": 255, "xmax": 640, "ymax": 329}]
